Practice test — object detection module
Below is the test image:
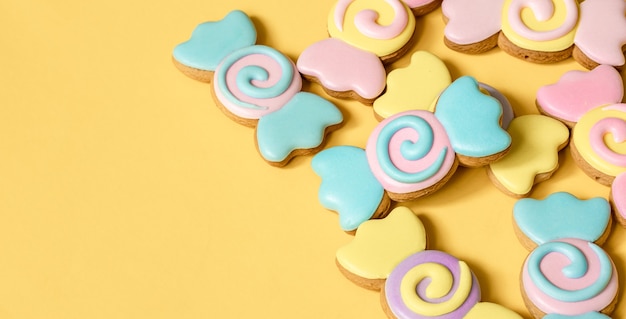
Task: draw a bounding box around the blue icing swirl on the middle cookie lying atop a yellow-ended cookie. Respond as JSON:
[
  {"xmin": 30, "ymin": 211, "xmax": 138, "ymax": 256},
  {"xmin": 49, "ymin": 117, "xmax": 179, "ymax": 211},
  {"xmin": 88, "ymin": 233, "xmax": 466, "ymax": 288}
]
[{"xmin": 376, "ymin": 115, "xmax": 448, "ymax": 183}]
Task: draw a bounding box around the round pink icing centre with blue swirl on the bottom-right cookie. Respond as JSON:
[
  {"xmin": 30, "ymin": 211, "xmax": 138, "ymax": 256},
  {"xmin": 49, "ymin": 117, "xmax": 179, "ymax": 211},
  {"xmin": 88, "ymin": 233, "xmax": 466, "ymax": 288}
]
[{"xmin": 522, "ymin": 239, "xmax": 618, "ymax": 316}]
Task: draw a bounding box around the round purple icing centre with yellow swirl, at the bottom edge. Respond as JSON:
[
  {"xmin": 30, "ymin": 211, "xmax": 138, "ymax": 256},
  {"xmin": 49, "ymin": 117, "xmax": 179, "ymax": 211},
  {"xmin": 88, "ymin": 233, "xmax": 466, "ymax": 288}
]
[{"xmin": 385, "ymin": 250, "xmax": 480, "ymax": 319}]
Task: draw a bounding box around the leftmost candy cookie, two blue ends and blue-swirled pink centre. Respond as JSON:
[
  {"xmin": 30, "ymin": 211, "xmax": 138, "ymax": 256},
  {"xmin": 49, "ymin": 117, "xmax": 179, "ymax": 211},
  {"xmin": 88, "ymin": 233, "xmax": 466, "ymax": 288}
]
[{"xmin": 173, "ymin": 10, "xmax": 343, "ymax": 166}]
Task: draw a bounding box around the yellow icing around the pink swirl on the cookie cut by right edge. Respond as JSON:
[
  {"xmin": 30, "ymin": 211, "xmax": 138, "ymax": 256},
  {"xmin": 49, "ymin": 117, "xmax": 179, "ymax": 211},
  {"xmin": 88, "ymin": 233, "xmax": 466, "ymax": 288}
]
[{"xmin": 572, "ymin": 107, "xmax": 626, "ymax": 176}]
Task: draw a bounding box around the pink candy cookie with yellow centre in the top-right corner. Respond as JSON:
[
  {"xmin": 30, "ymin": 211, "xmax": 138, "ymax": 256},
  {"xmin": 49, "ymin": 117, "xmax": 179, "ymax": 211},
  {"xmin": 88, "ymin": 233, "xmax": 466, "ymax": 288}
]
[{"xmin": 442, "ymin": 0, "xmax": 626, "ymax": 69}]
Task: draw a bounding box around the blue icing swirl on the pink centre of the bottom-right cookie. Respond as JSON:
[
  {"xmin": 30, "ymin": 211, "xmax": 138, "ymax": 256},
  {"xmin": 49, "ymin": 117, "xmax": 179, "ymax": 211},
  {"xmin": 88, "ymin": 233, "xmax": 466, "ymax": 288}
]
[{"xmin": 528, "ymin": 242, "xmax": 613, "ymax": 302}]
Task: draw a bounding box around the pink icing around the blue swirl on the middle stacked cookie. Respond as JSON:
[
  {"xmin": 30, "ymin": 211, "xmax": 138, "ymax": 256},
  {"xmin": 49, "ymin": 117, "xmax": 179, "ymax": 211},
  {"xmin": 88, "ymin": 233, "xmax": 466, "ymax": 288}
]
[{"xmin": 365, "ymin": 110, "xmax": 455, "ymax": 194}]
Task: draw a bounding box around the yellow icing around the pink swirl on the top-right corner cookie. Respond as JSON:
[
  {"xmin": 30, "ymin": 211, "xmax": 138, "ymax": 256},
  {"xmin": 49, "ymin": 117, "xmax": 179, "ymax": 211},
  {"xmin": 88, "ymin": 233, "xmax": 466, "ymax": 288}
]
[{"xmin": 502, "ymin": 0, "xmax": 578, "ymax": 52}]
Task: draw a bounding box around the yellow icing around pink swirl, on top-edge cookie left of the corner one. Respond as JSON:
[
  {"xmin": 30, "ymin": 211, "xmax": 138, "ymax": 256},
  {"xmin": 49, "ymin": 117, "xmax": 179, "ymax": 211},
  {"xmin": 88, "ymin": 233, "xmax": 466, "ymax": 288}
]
[{"xmin": 328, "ymin": 0, "xmax": 415, "ymax": 57}]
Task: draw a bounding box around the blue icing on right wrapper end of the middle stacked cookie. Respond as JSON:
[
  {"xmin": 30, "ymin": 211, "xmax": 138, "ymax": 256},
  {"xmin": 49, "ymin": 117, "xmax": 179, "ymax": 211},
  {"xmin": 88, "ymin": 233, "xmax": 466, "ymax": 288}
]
[{"xmin": 435, "ymin": 76, "xmax": 511, "ymax": 157}]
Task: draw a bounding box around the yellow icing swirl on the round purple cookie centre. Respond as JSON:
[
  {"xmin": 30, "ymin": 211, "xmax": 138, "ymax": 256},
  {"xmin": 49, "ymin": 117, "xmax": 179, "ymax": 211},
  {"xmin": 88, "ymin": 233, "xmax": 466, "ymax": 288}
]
[{"xmin": 400, "ymin": 261, "xmax": 472, "ymax": 317}]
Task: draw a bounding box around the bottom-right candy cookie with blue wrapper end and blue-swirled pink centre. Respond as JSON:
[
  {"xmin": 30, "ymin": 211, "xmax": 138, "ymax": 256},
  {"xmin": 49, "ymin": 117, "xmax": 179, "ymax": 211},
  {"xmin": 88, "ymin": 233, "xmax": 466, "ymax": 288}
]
[{"xmin": 514, "ymin": 193, "xmax": 618, "ymax": 318}]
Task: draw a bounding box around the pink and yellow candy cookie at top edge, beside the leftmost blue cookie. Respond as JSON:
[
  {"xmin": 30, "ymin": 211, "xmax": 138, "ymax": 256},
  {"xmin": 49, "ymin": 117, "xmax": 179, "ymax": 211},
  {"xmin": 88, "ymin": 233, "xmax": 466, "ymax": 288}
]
[{"xmin": 297, "ymin": 0, "xmax": 441, "ymax": 105}]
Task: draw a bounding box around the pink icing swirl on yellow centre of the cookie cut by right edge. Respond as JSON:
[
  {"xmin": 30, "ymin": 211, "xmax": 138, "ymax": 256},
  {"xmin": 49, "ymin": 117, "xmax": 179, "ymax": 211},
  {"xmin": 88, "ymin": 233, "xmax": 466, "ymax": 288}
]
[{"xmin": 589, "ymin": 117, "xmax": 626, "ymax": 168}]
